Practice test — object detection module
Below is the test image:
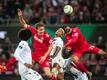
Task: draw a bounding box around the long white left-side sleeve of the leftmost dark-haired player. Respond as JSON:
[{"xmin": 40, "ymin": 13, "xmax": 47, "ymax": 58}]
[{"xmin": 14, "ymin": 43, "xmax": 26, "ymax": 64}]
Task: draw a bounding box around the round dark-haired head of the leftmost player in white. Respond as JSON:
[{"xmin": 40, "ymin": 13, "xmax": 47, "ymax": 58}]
[{"xmin": 18, "ymin": 29, "xmax": 32, "ymax": 41}]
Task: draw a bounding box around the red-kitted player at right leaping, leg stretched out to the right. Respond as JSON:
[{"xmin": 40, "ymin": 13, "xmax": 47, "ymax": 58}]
[{"xmin": 64, "ymin": 27, "xmax": 107, "ymax": 78}]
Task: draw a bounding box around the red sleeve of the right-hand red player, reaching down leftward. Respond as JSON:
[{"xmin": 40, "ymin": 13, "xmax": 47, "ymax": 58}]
[{"xmin": 65, "ymin": 29, "xmax": 79, "ymax": 46}]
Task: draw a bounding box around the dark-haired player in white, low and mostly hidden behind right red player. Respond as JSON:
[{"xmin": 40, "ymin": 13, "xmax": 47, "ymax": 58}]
[{"xmin": 62, "ymin": 47, "xmax": 88, "ymax": 80}]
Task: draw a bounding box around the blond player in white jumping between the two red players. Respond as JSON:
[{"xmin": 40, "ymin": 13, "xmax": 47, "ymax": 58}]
[{"xmin": 50, "ymin": 28, "xmax": 65, "ymax": 80}]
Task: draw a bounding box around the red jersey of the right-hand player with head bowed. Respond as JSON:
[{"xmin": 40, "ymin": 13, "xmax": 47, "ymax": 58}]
[{"xmin": 65, "ymin": 28, "xmax": 89, "ymax": 51}]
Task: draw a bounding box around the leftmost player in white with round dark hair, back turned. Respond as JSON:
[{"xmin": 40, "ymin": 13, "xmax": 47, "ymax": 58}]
[{"xmin": 14, "ymin": 29, "xmax": 42, "ymax": 80}]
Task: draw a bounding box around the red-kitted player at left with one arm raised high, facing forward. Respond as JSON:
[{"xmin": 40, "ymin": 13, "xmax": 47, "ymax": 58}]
[{"xmin": 0, "ymin": 9, "xmax": 54, "ymax": 80}]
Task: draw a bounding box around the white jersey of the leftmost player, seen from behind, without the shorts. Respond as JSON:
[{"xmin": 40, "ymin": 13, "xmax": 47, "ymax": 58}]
[{"xmin": 14, "ymin": 41, "xmax": 32, "ymax": 74}]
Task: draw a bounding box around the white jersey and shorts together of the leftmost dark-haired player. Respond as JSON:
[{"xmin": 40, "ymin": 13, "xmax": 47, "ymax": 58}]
[{"xmin": 14, "ymin": 41, "xmax": 42, "ymax": 80}]
